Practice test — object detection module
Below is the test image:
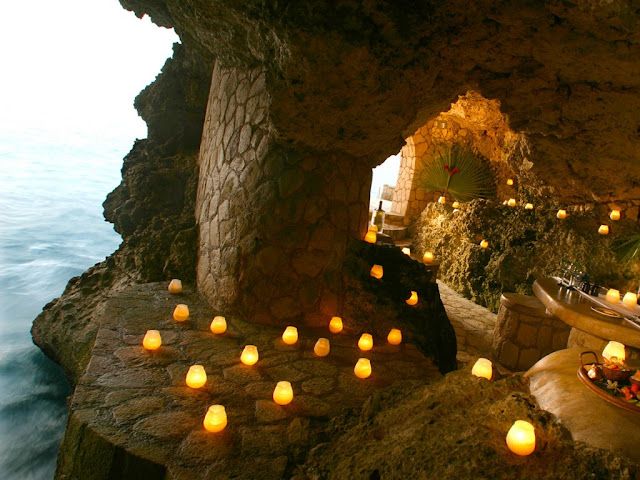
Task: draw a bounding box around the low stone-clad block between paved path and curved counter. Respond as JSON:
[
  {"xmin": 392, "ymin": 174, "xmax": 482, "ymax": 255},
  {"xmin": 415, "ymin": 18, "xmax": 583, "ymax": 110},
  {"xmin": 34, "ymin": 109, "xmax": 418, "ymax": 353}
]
[{"xmin": 492, "ymin": 293, "xmax": 571, "ymax": 371}]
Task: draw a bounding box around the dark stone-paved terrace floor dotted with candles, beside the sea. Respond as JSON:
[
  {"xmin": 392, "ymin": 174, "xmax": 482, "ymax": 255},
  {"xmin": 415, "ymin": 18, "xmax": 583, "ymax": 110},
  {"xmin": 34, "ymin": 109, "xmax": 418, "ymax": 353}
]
[{"xmin": 66, "ymin": 283, "xmax": 441, "ymax": 479}]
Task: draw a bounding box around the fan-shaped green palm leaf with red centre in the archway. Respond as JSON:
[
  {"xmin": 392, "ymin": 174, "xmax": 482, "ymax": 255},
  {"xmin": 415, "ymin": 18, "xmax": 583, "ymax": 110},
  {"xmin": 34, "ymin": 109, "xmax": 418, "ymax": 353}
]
[{"xmin": 417, "ymin": 143, "xmax": 493, "ymax": 202}]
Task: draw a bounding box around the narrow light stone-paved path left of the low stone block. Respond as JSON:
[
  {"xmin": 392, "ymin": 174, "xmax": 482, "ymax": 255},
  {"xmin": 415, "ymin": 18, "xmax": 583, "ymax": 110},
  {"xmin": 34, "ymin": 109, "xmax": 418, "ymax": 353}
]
[{"xmin": 438, "ymin": 280, "xmax": 496, "ymax": 360}]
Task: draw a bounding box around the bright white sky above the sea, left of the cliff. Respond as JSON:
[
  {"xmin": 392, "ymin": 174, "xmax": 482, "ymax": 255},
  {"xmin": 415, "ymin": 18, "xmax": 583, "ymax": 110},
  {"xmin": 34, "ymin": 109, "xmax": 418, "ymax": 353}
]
[{"xmin": 0, "ymin": 0, "xmax": 178, "ymax": 140}]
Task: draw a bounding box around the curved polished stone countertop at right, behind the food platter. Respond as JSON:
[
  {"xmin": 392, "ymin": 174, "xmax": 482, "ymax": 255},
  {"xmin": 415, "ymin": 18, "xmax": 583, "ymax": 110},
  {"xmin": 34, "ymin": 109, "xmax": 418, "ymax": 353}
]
[{"xmin": 533, "ymin": 277, "xmax": 640, "ymax": 349}]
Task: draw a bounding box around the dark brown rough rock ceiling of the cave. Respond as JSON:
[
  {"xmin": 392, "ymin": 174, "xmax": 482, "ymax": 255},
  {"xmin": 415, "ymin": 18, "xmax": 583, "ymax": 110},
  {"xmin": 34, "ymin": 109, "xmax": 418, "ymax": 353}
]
[{"xmin": 121, "ymin": 0, "xmax": 640, "ymax": 202}]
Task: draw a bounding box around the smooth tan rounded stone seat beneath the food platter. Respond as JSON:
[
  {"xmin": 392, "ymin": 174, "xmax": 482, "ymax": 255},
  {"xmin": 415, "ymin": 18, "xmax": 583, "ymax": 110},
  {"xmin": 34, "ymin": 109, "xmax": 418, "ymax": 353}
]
[{"xmin": 525, "ymin": 348, "xmax": 640, "ymax": 463}]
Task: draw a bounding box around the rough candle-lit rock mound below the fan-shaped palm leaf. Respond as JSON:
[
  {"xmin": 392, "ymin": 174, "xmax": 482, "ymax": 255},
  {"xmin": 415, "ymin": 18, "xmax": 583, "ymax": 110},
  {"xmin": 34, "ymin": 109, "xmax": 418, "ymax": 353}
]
[{"xmin": 414, "ymin": 200, "xmax": 640, "ymax": 312}]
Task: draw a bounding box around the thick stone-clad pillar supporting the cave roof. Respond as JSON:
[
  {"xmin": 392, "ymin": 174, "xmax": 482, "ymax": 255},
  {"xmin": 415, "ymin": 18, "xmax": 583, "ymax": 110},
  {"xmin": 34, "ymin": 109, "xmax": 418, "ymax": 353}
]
[{"xmin": 196, "ymin": 59, "xmax": 371, "ymax": 325}]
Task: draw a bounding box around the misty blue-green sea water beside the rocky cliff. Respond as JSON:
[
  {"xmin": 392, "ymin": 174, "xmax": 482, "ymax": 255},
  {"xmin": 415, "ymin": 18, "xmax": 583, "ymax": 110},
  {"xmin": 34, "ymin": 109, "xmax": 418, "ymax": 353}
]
[{"xmin": 0, "ymin": 130, "xmax": 127, "ymax": 480}]
